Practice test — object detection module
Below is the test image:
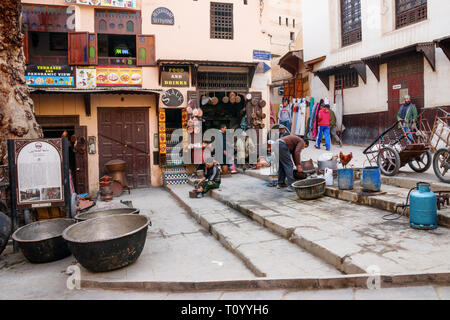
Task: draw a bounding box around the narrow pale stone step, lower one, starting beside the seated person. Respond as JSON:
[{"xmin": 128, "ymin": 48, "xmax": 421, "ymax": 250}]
[{"xmin": 166, "ymin": 185, "xmax": 342, "ymax": 278}]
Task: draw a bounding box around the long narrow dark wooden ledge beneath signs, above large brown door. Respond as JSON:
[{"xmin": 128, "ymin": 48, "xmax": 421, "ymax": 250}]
[{"xmin": 29, "ymin": 87, "xmax": 163, "ymax": 117}]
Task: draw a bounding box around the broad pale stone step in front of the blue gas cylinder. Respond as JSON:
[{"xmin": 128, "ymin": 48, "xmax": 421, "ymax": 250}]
[{"xmin": 212, "ymin": 175, "xmax": 450, "ymax": 274}]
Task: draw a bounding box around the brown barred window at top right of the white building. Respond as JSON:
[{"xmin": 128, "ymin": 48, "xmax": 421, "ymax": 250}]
[{"xmin": 395, "ymin": 0, "xmax": 427, "ymax": 29}]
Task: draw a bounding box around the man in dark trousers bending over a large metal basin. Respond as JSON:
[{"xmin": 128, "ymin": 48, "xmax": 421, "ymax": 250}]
[{"xmin": 277, "ymin": 134, "xmax": 309, "ymax": 192}]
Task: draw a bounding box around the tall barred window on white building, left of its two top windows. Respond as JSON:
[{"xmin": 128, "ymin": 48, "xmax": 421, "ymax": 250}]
[{"xmin": 341, "ymin": 0, "xmax": 362, "ymax": 47}]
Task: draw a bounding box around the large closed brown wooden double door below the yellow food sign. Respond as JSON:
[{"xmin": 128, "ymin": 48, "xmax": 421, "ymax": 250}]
[{"xmin": 98, "ymin": 108, "xmax": 151, "ymax": 188}]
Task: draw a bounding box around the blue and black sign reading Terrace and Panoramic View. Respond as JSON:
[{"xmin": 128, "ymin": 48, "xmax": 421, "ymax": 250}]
[{"xmin": 25, "ymin": 65, "xmax": 75, "ymax": 87}]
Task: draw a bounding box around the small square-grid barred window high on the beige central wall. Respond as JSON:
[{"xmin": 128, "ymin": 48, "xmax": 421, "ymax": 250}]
[{"xmin": 211, "ymin": 2, "xmax": 233, "ymax": 39}]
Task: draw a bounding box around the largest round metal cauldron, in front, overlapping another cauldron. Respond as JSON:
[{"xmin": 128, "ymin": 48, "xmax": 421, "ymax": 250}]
[{"xmin": 63, "ymin": 214, "xmax": 151, "ymax": 272}]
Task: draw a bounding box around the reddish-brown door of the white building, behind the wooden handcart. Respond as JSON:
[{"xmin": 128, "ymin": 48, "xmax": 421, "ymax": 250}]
[{"xmin": 385, "ymin": 53, "xmax": 424, "ymax": 128}]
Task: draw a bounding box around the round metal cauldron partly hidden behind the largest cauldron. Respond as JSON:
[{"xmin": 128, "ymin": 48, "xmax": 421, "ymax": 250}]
[{"xmin": 12, "ymin": 219, "xmax": 76, "ymax": 263}]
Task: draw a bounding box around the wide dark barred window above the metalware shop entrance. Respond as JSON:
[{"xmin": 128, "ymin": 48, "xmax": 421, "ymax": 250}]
[{"xmin": 197, "ymin": 72, "xmax": 248, "ymax": 91}]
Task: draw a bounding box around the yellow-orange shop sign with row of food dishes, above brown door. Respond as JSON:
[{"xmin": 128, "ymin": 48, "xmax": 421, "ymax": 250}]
[{"xmin": 96, "ymin": 67, "xmax": 142, "ymax": 87}]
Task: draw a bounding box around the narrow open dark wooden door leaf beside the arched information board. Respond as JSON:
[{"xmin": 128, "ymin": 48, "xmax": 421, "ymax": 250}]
[{"xmin": 73, "ymin": 126, "xmax": 89, "ymax": 194}]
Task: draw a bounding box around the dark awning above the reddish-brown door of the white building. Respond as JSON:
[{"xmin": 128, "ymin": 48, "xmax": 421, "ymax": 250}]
[{"xmin": 361, "ymin": 42, "xmax": 436, "ymax": 81}]
